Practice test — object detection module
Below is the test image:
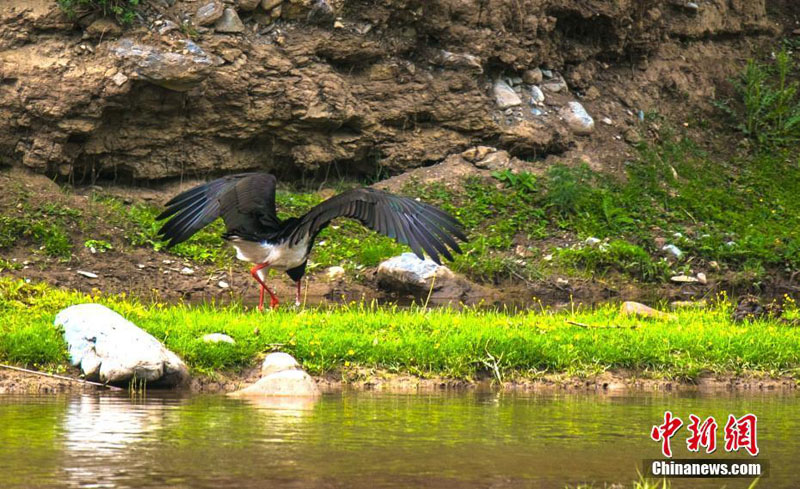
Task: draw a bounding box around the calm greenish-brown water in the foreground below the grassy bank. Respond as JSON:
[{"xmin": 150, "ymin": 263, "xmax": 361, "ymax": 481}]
[{"xmin": 0, "ymin": 392, "xmax": 800, "ymax": 489}]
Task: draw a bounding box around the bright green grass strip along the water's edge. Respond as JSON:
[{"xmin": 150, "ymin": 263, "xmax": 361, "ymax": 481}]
[{"xmin": 0, "ymin": 279, "xmax": 800, "ymax": 379}]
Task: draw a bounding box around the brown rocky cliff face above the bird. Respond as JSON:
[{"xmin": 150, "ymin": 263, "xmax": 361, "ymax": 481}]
[{"xmin": 0, "ymin": 0, "xmax": 774, "ymax": 179}]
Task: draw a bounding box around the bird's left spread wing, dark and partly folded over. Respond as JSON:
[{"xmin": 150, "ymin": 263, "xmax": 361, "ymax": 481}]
[{"xmin": 156, "ymin": 173, "xmax": 279, "ymax": 247}]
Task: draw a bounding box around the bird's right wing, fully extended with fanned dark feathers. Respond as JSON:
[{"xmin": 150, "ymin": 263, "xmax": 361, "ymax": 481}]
[{"xmin": 290, "ymin": 188, "xmax": 467, "ymax": 264}]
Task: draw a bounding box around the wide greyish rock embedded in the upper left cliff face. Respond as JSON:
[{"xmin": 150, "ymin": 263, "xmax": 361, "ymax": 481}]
[{"xmin": 111, "ymin": 39, "xmax": 216, "ymax": 92}]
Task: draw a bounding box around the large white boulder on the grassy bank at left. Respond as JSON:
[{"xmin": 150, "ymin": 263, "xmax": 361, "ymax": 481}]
[{"xmin": 54, "ymin": 304, "xmax": 189, "ymax": 386}]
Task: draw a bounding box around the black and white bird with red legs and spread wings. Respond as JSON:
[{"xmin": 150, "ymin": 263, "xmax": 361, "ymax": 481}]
[{"xmin": 156, "ymin": 172, "xmax": 467, "ymax": 311}]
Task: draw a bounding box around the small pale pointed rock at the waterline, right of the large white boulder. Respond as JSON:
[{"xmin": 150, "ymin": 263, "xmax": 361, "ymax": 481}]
[{"xmin": 230, "ymin": 352, "xmax": 320, "ymax": 397}]
